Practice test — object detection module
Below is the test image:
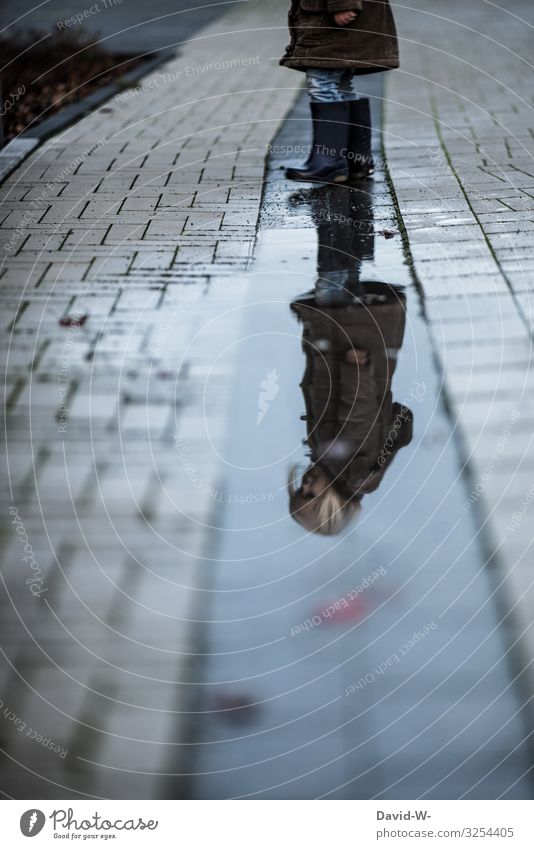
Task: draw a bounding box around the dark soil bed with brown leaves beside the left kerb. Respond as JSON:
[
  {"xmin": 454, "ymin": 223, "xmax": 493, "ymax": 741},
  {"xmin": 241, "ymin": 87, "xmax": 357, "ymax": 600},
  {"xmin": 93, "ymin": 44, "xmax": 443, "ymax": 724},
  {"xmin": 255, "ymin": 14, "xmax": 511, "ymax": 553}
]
[{"xmin": 0, "ymin": 30, "xmax": 147, "ymax": 143}]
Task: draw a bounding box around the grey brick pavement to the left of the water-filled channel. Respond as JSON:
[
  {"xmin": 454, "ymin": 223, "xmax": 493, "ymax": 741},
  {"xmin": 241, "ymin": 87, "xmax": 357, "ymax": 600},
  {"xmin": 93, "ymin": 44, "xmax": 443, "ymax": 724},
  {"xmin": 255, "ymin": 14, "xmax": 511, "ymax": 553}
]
[{"xmin": 0, "ymin": 0, "xmax": 298, "ymax": 798}]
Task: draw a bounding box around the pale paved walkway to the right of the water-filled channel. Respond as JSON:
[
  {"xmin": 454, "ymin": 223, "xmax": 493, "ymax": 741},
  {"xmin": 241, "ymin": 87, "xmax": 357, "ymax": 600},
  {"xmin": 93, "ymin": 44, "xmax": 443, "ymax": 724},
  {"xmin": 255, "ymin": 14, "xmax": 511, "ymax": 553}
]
[{"xmin": 385, "ymin": 0, "xmax": 534, "ymax": 694}]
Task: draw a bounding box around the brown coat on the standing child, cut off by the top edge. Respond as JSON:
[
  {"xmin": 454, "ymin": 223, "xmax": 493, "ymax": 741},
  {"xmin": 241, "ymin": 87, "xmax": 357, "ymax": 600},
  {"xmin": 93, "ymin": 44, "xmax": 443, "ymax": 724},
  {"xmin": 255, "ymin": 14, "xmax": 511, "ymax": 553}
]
[{"xmin": 280, "ymin": 0, "xmax": 399, "ymax": 74}]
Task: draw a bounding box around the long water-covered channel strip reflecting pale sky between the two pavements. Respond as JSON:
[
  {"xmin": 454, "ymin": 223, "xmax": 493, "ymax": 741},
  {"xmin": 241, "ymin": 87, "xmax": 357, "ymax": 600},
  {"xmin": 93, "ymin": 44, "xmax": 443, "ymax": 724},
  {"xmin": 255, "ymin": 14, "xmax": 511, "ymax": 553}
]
[{"xmin": 194, "ymin": 89, "xmax": 532, "ymax": 799}]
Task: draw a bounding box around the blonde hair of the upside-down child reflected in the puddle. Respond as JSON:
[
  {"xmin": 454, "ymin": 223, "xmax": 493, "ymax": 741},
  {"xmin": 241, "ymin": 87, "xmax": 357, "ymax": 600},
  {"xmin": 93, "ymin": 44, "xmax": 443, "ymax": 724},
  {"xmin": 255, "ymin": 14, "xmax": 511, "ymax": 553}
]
[{"xmin": 287, "ymin": 465, "xmax": 361, "ymax": 536}]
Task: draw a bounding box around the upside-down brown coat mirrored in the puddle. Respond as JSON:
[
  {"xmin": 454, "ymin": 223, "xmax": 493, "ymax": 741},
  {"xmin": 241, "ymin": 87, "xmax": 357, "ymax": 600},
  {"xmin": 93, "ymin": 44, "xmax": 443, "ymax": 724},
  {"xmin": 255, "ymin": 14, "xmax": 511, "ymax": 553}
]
[{"xmin": 292, "ymin": 284, "xmax": 413, "ymax": 499}]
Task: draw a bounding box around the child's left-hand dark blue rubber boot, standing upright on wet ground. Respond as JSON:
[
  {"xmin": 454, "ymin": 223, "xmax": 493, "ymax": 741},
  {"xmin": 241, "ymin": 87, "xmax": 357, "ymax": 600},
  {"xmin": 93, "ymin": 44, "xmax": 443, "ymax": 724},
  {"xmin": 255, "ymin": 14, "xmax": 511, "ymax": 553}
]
[{"xmin": 286, "ymin": 101, "xmax": 349, "ymax": 183}]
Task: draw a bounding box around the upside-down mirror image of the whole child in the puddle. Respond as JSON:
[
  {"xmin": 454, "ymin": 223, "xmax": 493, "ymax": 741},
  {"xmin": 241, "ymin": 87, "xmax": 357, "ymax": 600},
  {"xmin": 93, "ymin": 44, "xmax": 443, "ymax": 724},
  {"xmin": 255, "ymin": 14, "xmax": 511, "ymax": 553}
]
[{"xmin": 289, "ymin": 186, "xmax": 413, "ymax": 535}]
